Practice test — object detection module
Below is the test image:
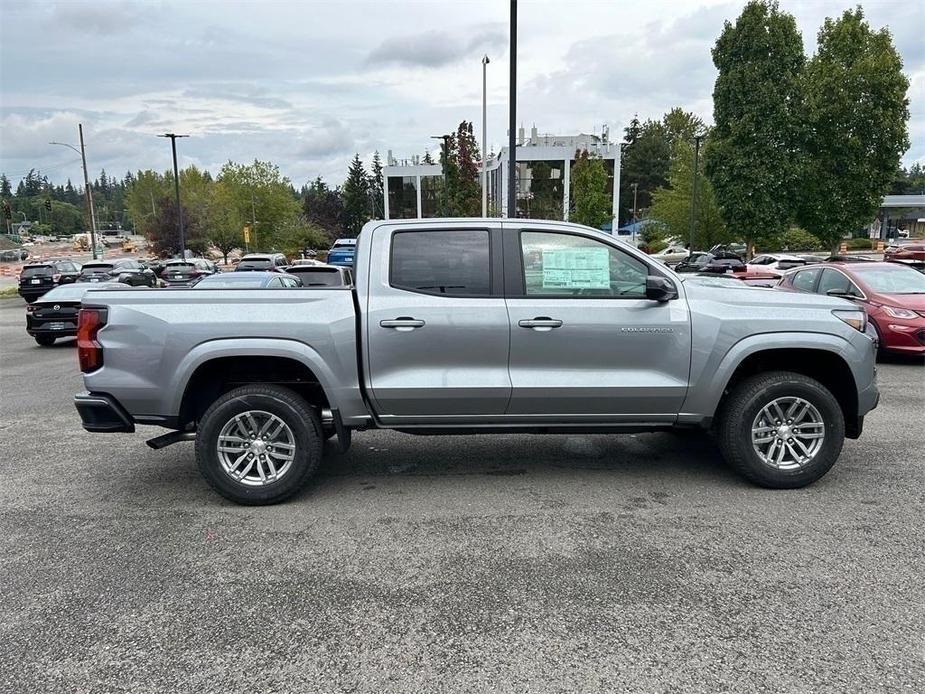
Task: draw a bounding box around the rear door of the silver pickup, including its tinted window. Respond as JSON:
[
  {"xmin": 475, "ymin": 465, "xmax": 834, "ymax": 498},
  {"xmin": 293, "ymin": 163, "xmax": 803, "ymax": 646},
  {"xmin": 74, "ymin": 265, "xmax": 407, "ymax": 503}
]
[{"xmin": 364, "ymin": 223, "xmax": 511, "ymax": 424}]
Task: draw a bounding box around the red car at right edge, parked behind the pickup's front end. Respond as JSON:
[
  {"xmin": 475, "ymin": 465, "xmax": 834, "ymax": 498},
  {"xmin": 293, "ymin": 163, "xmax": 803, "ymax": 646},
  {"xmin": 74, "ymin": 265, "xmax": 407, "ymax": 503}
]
[{"xmin": 779, "ymin": 263, "xmax": 925, "ymax": 355}]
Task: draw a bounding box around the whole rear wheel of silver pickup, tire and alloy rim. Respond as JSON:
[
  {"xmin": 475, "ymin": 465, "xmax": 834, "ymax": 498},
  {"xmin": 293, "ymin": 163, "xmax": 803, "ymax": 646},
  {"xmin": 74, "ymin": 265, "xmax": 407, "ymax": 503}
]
[{"xmin": 196, "ymin": 384, "xmax": 323, "ymax": 505}]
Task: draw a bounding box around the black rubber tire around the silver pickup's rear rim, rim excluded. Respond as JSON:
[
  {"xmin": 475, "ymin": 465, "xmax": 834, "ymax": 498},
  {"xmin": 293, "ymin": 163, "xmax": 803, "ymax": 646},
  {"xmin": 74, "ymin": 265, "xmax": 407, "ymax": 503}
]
[{"xmin": 196, "ymin": 384, "xmax": 323, "ymax": 506}]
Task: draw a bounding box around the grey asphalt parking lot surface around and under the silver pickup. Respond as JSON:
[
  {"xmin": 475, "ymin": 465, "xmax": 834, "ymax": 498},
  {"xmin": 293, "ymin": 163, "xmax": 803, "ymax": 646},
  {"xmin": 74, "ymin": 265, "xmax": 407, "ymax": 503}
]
[{"xmin": 0, "ymin": 299, "xmax": 925, "ymax": 692}]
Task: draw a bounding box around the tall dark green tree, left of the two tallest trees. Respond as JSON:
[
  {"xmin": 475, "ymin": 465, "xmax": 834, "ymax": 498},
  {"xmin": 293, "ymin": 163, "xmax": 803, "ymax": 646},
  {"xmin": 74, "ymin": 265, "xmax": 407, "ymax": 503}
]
[{"xmin": 705, "ymin": 0, "xmax": 805, "ymax": 253}]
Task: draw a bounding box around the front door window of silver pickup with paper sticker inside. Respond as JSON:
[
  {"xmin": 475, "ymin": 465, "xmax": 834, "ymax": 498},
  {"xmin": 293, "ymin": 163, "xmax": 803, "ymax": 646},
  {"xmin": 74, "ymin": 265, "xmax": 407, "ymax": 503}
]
[{"xmin": 520, "ymin": 231, "xmax": 649, "ymax": 299}]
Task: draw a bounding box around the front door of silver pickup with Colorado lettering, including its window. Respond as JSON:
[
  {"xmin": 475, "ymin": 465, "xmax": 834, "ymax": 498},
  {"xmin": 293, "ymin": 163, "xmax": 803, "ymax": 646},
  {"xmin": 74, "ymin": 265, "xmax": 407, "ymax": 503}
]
[{"xmin": 504, "ymin": 231, "xmax": 691, "ymax": 423}]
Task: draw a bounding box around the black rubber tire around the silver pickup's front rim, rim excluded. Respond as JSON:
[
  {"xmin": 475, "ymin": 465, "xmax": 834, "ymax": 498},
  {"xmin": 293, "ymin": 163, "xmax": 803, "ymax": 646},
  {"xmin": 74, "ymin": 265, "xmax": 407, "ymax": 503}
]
[{"xmin": 716, "ymin": 371, "xmax": 845, "ymax": 489}]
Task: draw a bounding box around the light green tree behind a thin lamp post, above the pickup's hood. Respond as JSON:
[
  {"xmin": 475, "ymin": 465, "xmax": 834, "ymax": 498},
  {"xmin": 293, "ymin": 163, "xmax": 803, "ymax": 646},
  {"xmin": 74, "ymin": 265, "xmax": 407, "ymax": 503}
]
[{"xmin": 646, "ymin": 138, "xmax": 731, "ymax": 250}]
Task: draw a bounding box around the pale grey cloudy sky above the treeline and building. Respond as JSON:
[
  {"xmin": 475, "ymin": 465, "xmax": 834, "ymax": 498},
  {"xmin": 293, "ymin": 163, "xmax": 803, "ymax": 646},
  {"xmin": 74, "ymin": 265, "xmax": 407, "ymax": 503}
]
[{"xmin": 0, "ymin": 0, "xmax": 925, "ymax": 186}]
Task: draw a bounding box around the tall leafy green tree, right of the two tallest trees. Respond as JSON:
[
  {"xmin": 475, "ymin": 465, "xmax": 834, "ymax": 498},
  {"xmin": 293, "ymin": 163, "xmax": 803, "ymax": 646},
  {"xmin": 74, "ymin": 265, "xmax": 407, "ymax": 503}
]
[{"xmin": 799, "ymin": 7, "xmax": 909, "ymax": 251}]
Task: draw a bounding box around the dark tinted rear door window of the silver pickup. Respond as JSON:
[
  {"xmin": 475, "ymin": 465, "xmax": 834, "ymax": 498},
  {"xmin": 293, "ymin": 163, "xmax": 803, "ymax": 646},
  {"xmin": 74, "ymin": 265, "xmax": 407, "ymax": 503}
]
[{"xmin": 389, "ymin": 229, "xmax": 491, "ymax": 296}]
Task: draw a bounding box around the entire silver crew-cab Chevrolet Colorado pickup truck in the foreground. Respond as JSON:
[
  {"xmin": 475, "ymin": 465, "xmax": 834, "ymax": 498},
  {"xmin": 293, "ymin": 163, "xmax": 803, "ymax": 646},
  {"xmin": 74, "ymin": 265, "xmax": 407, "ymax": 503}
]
[{"xmin": 76, "ymin": 219, "xmax": 879, "ymax": 504}]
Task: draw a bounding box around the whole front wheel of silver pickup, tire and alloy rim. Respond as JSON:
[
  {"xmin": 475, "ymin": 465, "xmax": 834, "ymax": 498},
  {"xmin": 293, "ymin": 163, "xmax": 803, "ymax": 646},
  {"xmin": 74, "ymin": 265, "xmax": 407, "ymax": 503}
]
[{"xmin": 717, "ymin": 371, "xmax": 845, "ymax": 489}]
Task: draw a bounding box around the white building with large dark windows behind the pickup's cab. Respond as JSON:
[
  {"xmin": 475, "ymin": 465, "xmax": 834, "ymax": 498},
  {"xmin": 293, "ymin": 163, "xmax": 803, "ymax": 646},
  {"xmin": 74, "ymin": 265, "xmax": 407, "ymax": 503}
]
[{"xmin": 382, "ymin": 126, "xmax": 620, "ymax": 220}]
